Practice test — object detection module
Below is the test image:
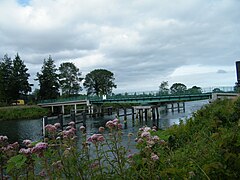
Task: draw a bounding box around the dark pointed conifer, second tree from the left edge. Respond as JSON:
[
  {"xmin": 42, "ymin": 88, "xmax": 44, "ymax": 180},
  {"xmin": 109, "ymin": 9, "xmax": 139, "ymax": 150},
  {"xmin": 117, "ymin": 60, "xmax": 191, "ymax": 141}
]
[{"xmin": 11, "ymin": 54, "xmax": 31, "ymax": 100}]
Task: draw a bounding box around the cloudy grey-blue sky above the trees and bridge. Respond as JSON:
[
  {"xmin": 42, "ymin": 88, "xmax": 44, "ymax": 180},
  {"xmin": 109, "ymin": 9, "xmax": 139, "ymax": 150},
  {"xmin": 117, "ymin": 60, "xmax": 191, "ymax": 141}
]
[{"xmin": 0, "ymin": 0, "xmax": 240, "ymax": 92}]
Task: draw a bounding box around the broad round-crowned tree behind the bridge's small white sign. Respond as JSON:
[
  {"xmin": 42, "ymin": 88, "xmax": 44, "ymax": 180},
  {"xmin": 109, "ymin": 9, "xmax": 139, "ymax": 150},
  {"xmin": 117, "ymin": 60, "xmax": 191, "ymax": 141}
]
[{"xmin": 83, "ymin": 69, "xmax": 117, "ymax": 96}]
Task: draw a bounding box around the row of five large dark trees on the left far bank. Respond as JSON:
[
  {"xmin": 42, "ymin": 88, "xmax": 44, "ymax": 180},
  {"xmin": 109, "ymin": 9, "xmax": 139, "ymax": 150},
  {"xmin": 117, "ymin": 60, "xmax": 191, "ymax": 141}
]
[{"xmin": 0, "ymin": 54, "xmax": 117, "ymax": 104}]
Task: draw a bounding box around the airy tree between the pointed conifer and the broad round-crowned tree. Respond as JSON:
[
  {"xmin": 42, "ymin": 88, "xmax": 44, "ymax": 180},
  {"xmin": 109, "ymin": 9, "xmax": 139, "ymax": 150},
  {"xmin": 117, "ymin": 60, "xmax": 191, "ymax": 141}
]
[{"xmin": 59, "ymin": 62, "xmax": 83, "ymax": 96}]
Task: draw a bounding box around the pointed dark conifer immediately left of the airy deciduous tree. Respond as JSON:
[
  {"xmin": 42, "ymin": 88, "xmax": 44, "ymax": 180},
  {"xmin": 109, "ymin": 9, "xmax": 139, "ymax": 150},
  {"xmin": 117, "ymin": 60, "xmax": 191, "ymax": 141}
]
[{"xmin": 36, "ymin": 56, "xmax": 59, "ymax": 99}]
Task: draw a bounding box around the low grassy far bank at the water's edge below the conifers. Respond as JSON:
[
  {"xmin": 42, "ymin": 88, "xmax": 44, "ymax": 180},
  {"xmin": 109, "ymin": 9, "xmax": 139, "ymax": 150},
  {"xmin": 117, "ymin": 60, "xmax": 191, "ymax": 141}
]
[{"xmin": 0, "ymin": 106, "xmax": 48, "ymax": 121}]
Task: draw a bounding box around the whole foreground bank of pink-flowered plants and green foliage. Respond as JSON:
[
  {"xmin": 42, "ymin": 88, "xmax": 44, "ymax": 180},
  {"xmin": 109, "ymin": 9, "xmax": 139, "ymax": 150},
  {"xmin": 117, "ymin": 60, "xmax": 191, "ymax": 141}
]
[{"xmin": 0, "ymin": 99, "xmax": 240, "ymax": 180}]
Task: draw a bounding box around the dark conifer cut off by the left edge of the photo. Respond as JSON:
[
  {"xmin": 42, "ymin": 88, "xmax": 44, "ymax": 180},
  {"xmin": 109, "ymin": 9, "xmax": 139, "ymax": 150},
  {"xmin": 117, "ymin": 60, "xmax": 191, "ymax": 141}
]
[{"xmin": 0, "ymin": 54, "xmax": 13, "ymax": 103}]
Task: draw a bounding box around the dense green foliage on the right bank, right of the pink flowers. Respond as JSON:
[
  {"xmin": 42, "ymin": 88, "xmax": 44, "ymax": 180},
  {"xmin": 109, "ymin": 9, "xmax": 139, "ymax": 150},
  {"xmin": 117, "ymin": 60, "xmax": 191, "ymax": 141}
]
[{"xmin": 154, "ymin": 99, "xmax": 240, "ymax": 179}]
